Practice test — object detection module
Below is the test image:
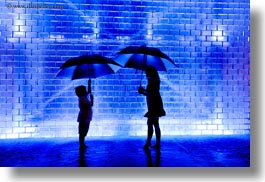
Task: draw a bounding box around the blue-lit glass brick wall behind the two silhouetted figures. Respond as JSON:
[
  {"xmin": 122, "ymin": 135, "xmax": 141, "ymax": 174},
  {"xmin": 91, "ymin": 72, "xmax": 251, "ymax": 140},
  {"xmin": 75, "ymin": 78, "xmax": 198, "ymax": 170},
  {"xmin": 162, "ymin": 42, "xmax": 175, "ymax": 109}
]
[{"xmin": 0, "ymin": 0, "xmax": 250, "ymax": 138}]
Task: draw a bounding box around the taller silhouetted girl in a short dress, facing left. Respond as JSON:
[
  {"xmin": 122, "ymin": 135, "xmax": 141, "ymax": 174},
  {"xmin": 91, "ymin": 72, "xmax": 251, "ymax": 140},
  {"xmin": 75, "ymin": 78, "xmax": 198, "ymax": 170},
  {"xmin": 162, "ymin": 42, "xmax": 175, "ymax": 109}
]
[{"xmin": 138, "ymin": 66, "xmax": 166, "ymax": 149}]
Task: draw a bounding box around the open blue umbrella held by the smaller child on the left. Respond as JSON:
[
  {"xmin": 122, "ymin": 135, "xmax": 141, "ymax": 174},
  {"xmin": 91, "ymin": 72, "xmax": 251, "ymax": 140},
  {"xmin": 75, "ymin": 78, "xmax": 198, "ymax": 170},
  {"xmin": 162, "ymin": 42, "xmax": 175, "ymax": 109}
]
[{"xmin": 56, "ymin": 54, "xmax": 120, "ymax": 92}]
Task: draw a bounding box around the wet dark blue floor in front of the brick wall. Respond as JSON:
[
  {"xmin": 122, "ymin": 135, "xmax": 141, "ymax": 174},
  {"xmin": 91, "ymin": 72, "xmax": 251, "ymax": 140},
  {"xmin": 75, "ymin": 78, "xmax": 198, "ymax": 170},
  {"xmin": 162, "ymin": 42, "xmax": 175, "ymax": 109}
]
[{"xmin": 0, "ymin": 136, "xmax": 250, "ymax": 167}]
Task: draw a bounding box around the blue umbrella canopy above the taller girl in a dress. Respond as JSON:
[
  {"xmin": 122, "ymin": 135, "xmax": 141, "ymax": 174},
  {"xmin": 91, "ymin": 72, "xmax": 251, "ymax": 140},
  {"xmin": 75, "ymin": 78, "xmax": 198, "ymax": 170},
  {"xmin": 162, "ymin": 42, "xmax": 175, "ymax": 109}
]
[{"xmin": 114, "ymin": 46, "xmax": 175, "ymax": 71}]
